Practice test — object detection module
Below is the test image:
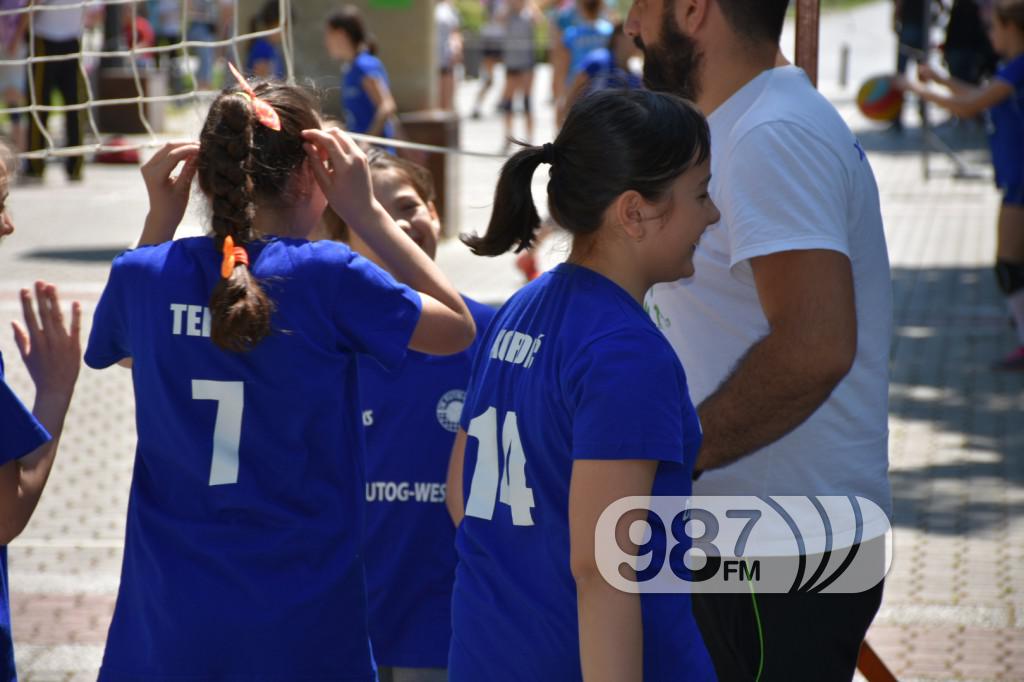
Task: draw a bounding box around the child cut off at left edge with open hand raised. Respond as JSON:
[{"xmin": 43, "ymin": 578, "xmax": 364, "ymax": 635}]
[{"xmin": 0, "ymin": 144, "xmax": 82, "ymax": 682}]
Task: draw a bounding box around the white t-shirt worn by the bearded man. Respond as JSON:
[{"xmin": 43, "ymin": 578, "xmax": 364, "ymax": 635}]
[{"xmin": 647, "ymin": 67, "xmax": 892, "ymax": 540}]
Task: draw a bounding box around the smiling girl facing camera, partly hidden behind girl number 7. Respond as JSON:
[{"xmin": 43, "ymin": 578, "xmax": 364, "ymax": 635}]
[{"xmin": 323, "ymin": 150, "xmax": 495, "ymax": 682}]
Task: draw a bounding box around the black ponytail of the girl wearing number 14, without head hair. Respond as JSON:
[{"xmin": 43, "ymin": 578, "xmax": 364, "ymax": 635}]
[{"xmin": 461, "ymin": 144, "xmax": 554, "ymax": 256}]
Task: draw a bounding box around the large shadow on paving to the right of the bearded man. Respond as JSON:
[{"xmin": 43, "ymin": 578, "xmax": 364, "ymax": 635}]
[{"xmin": 889, "ymin": 267, "xmax": 1024, "ymax": 535}]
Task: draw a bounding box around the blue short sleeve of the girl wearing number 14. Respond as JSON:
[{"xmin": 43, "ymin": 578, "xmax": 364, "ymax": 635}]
[{"xmin": 566, "ymin": 328, "xmax": 692, "ymax": 464}]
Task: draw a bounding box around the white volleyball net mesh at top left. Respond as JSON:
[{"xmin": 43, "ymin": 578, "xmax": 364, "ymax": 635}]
[{"xmin": 6, "ymin": 0, "xmax": 294, "ymax": 160}]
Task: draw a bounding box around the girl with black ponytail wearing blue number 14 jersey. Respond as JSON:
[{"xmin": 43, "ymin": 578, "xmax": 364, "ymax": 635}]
[{"xmin": 449, "ymin": 90, "xmax": 719, "ymax": 682}]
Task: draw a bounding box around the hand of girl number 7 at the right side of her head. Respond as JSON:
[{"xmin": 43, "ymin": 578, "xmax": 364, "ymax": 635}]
[{"xmin": 302, "ymin": 128, "xmax": 376, "ymax": 227}]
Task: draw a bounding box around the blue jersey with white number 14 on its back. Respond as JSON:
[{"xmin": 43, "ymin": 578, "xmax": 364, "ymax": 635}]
[{"xmin": 449, "ymin": 264, "xmax": 715, "ymax": 682}]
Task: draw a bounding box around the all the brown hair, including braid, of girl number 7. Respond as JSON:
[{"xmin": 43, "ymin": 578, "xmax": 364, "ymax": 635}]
[{"xmin": 198, "ymin": 83, "xmax": 319, "ymax": 352}]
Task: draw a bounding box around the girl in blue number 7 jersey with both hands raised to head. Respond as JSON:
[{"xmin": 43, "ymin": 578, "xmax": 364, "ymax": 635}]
[{"xmin": 86, "ymin": 78, "xmax": 474, "ymax": 682}]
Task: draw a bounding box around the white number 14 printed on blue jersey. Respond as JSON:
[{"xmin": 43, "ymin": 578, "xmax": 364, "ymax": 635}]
[{"xmin": 466, "ymin": 408, "xmax": 534, "ymax": 525}]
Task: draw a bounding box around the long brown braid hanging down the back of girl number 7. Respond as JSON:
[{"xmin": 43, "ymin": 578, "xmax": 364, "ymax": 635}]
[{"xmin": 199, "ymin": 93, "xmax": 273, "ymax": 353}]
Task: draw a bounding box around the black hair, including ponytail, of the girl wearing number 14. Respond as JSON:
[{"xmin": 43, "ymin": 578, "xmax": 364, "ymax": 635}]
[{"xmin": 462, "ymin": 90, "xmax": 711, "ymax": 256}]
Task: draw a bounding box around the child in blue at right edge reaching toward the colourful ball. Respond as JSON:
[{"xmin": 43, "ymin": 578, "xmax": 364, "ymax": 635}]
[{"xmin": 897, "ymin": 0, "xmax": 1024, "ymax": 372}]
